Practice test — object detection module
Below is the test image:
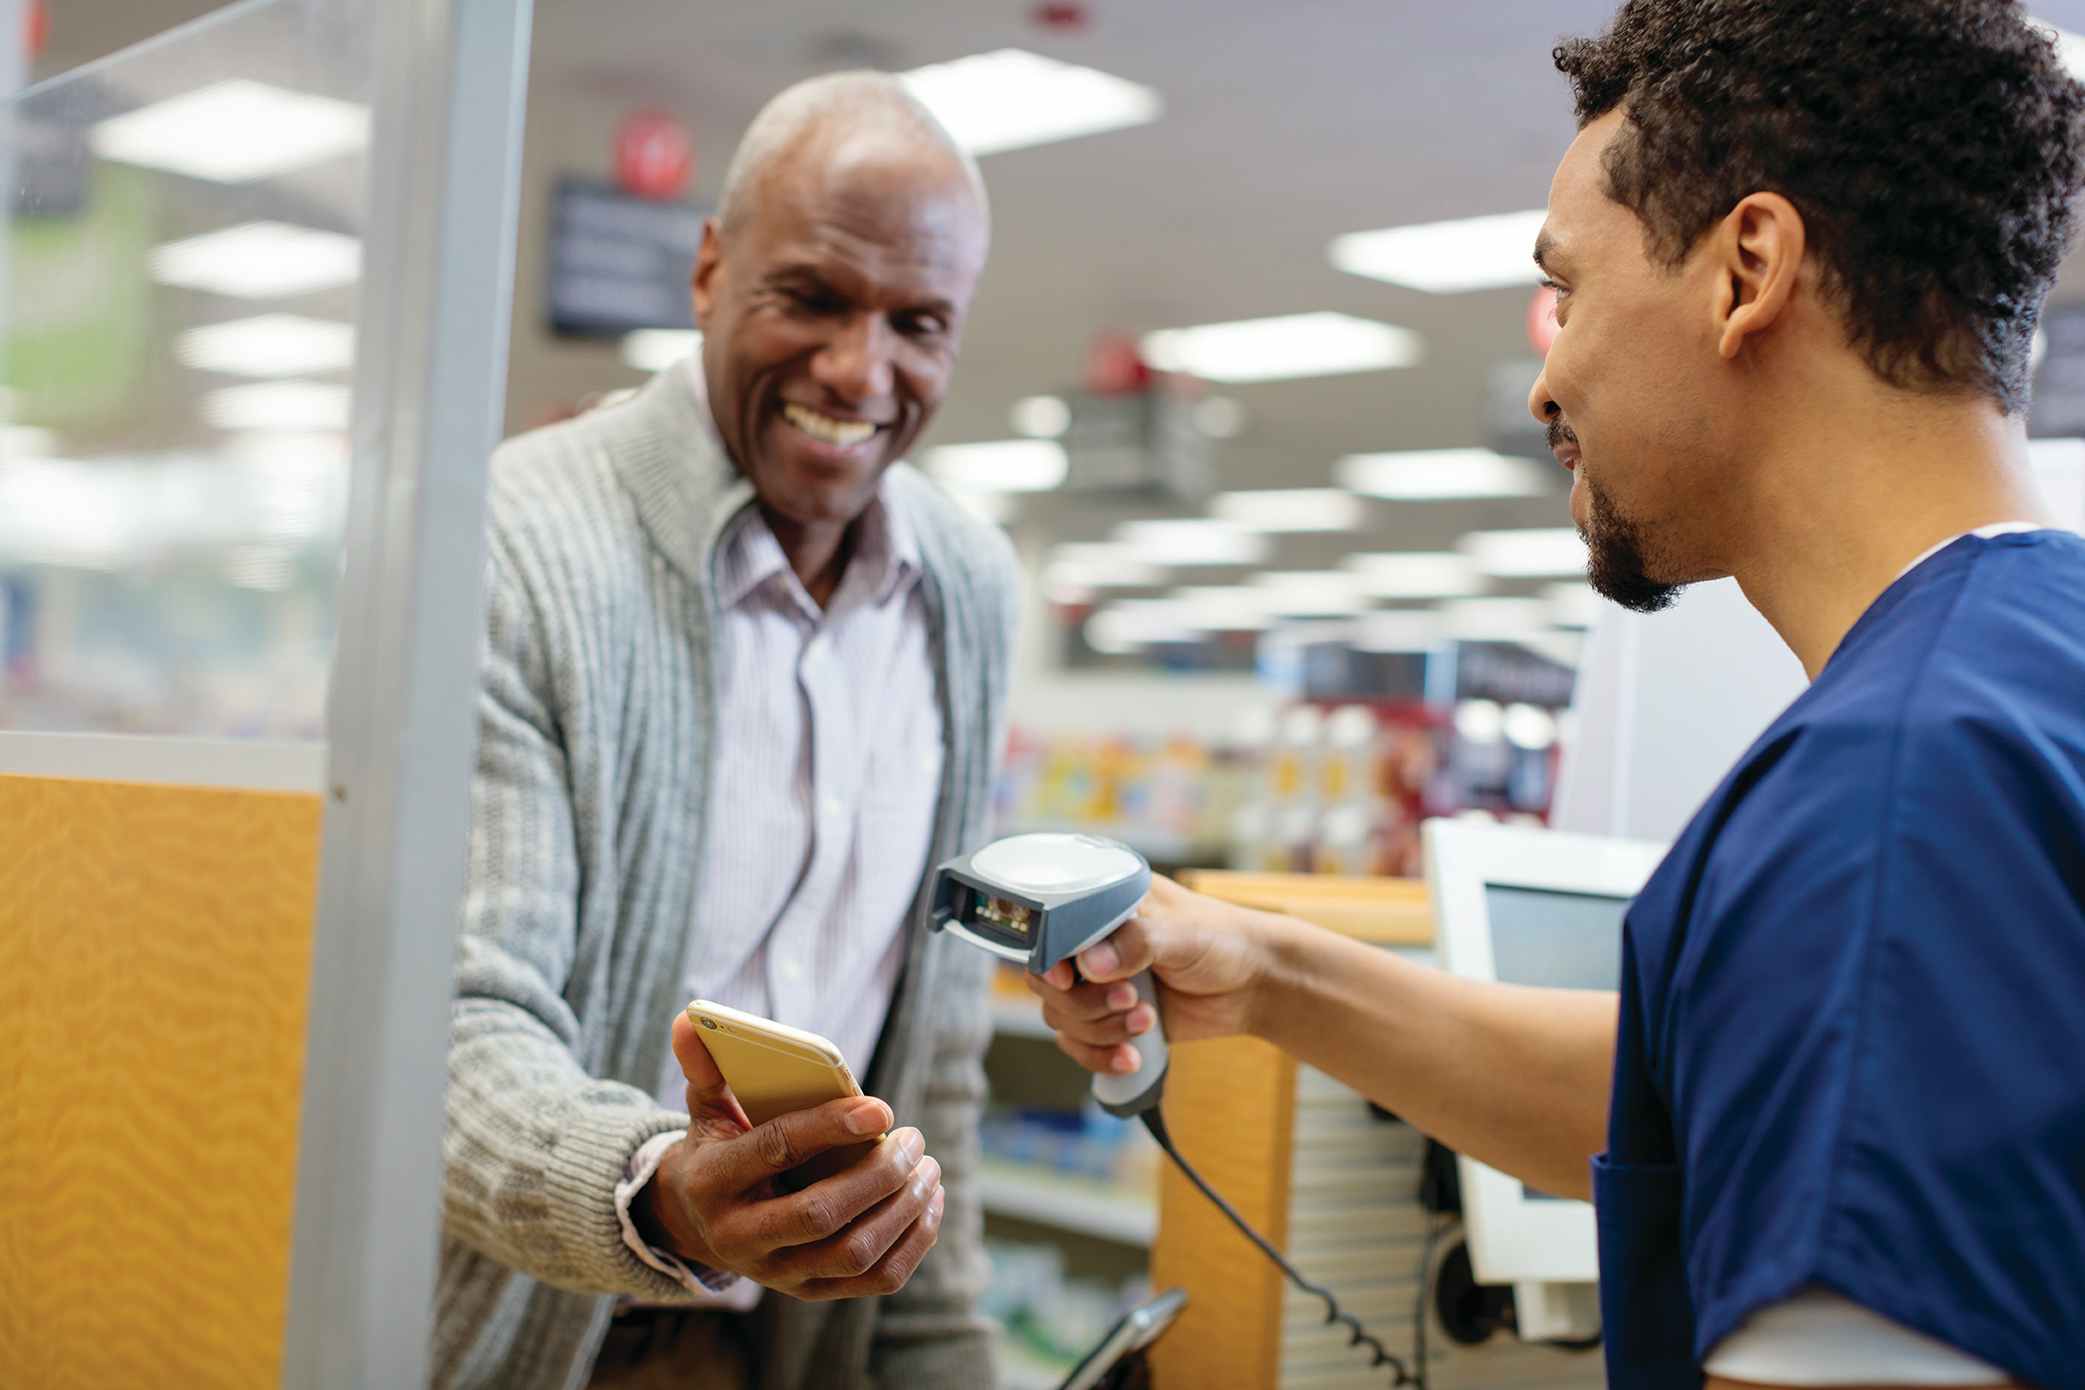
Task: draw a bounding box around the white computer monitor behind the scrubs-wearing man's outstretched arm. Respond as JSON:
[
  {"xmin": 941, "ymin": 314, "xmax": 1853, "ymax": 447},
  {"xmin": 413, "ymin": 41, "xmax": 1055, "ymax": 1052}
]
[{"xmin": 1424, "ymin": 821, "xmax": 1666, "ymax": 1286}]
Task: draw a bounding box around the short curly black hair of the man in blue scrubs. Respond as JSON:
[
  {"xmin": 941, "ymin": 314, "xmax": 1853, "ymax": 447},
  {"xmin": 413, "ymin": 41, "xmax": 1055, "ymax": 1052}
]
[{"xmin": 1555, "ymin": 0, "xmax": 2085, "ymax": 413}]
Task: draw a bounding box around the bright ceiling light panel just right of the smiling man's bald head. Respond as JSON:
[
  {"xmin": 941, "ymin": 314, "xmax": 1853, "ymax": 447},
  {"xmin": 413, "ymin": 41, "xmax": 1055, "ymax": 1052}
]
[{"xmin": 905, "ymin": 48, "xmax": 1166, "ymax": 154}]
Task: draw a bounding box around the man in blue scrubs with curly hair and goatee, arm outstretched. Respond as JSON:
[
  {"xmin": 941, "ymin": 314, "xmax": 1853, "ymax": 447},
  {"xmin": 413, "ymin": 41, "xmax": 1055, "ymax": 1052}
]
[{"xmin": 1038, "ymin": 0, "xmax": 2085, "ymax": 1390}]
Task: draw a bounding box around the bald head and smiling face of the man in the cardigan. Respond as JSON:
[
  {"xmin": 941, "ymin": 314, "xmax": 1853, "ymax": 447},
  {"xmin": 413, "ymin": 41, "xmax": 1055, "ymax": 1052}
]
[{"xmin": 692, "ymin": 73, "xmax": 990, "ymax": 550}]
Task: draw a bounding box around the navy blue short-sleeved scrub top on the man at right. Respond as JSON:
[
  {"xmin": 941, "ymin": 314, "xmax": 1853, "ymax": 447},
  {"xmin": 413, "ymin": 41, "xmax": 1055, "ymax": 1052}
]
[{"xmin": 1593, "ymin": 531, "xmax": 2085, "ymax": 1390}]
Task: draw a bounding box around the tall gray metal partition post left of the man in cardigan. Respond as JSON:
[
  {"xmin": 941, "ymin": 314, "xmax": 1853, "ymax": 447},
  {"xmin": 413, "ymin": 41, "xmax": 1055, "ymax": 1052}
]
[{"xmin": 284, "ymin": 0, "xmax": 532, "ymax": 1390}]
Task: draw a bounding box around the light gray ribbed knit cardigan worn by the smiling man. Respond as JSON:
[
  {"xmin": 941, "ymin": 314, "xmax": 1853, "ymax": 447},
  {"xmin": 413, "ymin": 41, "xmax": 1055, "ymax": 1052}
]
[{"xmin": 434, "ymin": 365, "xmax": 1015, "ymax": 1390}]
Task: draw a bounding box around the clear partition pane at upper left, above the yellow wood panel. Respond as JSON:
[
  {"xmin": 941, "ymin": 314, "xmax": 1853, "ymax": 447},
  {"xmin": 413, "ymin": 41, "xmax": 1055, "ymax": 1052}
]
[{"xmin": 0, "ymin": 0, "xmax": 382, "ymax": 740}]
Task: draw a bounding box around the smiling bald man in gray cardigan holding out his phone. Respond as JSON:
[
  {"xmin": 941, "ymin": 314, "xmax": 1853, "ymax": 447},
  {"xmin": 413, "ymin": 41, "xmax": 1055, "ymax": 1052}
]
[{"xmin": 436, "ymin": 73, "xmax": 1015, "ymax": 1390}]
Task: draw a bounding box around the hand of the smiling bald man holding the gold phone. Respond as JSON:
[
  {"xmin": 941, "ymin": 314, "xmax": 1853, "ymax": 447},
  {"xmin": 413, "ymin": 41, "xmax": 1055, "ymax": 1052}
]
[{"xmin": 634, "ymin": 1015, "xmax": 947, "ymax": 1300}]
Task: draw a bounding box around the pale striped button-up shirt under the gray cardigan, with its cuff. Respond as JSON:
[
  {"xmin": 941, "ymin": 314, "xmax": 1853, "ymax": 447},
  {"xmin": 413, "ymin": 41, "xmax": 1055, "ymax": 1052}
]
[{"xmin": 617, "ymin": 363, "xmax": 945, "ymax": 1307}]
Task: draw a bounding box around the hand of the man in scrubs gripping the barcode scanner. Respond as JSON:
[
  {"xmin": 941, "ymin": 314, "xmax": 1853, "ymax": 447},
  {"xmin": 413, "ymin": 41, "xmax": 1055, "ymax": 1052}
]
[{"xmin": 1028, "ymin": 877, "xmax": 1266, "ymax": 1073}]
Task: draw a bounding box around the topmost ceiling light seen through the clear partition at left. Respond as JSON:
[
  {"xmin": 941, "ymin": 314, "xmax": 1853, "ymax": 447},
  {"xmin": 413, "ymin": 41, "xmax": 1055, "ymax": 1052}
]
[{"xmin": 90, "ymin": 79, "xmax": 369, "ymax": 183}]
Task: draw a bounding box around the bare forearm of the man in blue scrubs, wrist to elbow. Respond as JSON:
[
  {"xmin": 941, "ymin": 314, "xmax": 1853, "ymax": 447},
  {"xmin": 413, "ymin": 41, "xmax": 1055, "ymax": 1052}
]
[{"xmin": 1253, "ymin": 919, "xmax": 1618, "ymax": 1196}]
